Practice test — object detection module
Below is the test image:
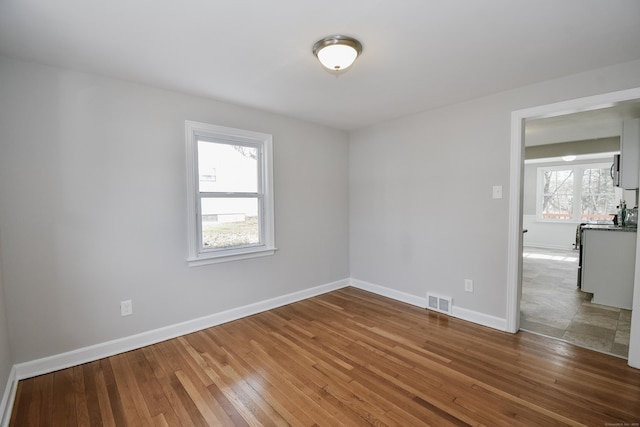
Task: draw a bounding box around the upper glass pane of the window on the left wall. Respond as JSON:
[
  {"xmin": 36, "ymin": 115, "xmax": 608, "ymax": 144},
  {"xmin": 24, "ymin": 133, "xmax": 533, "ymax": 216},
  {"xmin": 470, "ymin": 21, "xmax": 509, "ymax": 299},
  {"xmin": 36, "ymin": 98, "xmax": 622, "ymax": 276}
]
[{"xmin": 198, "ymin": 140, "xmax": 258, "ymax": 193}]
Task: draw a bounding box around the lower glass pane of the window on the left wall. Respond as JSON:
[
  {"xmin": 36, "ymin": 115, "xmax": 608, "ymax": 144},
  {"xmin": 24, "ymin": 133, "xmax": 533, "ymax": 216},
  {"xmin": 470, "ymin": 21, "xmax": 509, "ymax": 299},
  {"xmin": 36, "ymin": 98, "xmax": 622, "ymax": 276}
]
[{"xmin": 201, "ymin": 198, "xmax": 261, "ymax": 249}]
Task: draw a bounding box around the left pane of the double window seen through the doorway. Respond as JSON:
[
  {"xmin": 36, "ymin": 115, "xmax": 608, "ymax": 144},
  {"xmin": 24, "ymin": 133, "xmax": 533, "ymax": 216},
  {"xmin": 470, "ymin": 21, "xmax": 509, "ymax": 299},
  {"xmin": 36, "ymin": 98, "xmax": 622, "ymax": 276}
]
[{"xmin": 542, "ymin": 169, "xmax": 573, "ymax": 220}]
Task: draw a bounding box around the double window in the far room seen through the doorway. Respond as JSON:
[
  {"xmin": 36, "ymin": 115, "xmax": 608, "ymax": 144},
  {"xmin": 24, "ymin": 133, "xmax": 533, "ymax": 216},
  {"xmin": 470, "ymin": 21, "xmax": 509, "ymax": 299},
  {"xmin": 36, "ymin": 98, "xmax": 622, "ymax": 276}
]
[{"xmin": 537, "ymin": 164, "xmax": 616, "ymax": 222}]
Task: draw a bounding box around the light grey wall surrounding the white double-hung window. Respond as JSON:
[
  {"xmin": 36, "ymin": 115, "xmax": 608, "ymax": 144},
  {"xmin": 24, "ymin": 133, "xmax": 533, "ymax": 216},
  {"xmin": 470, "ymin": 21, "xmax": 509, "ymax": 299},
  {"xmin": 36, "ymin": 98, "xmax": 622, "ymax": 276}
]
[{"xmin": 0, "ymin": 57, "xmax": 349, "ymax": 364}]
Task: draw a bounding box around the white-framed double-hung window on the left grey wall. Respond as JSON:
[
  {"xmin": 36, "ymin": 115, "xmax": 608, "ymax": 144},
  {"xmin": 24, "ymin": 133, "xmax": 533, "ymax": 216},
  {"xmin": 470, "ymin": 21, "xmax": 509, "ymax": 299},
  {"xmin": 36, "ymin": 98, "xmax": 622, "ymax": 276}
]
[{"xmin": 185, "ymin": 121, "xmax": 275, "ymax": 266}]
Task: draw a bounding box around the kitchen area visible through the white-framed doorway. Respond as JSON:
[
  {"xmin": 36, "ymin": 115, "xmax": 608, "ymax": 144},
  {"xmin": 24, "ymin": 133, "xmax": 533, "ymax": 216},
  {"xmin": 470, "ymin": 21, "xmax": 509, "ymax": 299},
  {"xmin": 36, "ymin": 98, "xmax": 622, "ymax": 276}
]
[{"xmin": 520, "ymin": 101, "xmax": 640, "ymax": 358}]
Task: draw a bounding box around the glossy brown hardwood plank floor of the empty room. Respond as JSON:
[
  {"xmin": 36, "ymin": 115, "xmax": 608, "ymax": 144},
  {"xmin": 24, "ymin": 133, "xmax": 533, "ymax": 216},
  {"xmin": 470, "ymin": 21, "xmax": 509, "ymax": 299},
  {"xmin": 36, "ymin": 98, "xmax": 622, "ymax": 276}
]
[{"xmin": 11, "ymin": 288, "xmax": 640, "ymax": 426}]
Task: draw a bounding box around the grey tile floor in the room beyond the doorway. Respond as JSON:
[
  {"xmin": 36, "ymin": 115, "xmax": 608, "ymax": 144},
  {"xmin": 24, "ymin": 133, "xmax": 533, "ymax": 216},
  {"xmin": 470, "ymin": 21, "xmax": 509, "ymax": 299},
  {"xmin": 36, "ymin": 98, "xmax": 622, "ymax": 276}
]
[{"xmin": 520, "ymin": 247, "xmax": 631, "ymax": 359}]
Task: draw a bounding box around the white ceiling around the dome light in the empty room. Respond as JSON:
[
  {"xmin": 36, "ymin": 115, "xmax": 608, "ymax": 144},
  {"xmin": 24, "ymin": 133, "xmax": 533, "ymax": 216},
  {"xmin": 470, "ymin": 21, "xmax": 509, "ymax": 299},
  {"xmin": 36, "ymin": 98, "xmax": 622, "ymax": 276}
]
[{"xmin": 0, "ymin": 0, "xmax": 640, "ymax": 130}]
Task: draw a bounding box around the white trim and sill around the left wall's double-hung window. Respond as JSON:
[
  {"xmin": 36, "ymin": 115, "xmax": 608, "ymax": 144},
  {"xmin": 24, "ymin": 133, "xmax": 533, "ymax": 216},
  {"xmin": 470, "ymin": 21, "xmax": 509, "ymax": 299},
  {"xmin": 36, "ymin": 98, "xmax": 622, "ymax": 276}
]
[{"xmin": 185, "ymin": 120, "xmax": 277, "ymax": 267}]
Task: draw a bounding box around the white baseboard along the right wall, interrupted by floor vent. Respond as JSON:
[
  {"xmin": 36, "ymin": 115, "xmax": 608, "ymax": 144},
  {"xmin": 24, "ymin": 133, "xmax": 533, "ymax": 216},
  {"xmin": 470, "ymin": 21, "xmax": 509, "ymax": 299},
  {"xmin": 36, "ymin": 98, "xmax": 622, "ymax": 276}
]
[{"xmin": 351, "ymin": 279, "xmax": 507, "ymax": 331}]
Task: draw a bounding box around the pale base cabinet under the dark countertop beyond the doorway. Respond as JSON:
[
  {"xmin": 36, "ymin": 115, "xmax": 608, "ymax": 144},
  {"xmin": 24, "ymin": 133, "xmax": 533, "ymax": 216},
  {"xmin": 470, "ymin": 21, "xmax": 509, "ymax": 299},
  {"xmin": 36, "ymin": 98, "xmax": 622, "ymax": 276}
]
[{"xmin": 581, "ymin": 229, "xmax": 637, "ymax": 310}]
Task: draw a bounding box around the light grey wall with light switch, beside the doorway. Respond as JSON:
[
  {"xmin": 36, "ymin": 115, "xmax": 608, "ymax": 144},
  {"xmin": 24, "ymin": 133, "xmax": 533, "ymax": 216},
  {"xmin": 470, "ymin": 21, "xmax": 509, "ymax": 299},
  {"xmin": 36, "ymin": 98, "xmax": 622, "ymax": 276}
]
[{"xmin": 349, "ymin": 61, "xmax": 640, "ymax": 318}]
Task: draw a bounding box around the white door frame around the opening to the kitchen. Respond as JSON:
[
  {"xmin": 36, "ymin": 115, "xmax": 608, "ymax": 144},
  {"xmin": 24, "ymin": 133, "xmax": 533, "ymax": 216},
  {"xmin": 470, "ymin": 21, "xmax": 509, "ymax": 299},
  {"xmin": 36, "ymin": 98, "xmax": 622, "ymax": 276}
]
[{"xmin": 506, "ymin": 87, "xmax": 640, "ymax": 366}]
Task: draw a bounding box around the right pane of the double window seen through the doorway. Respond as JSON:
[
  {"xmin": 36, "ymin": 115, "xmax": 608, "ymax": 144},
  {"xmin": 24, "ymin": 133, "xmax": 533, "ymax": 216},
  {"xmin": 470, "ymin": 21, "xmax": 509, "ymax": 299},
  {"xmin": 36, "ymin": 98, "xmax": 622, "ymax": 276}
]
[{"xmin": 581, "ymin": 168, "xmax": 616, "ymax": 220}]
